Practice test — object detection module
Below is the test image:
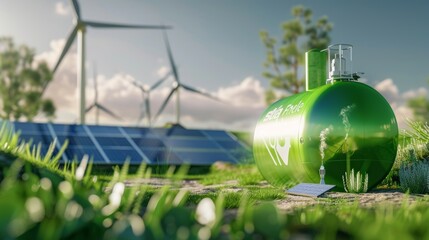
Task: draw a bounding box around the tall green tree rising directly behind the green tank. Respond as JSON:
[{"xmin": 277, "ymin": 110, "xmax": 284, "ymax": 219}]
[{"xmin": 260, "ymin": 6, "xmax": 332, "ymax": 103}]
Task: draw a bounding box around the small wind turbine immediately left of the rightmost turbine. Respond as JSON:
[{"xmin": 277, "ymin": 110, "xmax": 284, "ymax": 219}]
[{"xmin": 132, "ymin": 72, "xmax": 171, "ymax": 127}]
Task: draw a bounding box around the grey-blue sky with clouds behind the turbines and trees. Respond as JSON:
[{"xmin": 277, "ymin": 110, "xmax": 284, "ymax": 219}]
[{"xmin": 0, "ymin": 0, "xmax": 429, "ymax": 130}]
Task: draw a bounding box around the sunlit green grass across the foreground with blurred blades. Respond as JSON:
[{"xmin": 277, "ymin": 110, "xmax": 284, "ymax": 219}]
[{"xmin": 0, "ymin": 123, "xmax": 429, "ymax": 239}]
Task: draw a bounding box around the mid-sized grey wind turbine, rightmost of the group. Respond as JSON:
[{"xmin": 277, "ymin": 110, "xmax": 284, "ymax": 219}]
[{"xmin": 154, "ymin": 31, "xmax": 220, "ymax": 124}]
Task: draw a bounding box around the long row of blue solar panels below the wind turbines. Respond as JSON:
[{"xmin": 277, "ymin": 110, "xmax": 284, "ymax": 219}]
[{"xmin": 11, "ymin": 122, "xmax": 251, "ymax": 165}]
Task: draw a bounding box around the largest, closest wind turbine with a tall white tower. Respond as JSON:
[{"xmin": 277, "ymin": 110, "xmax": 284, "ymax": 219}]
[{"xmin": 50, "ymin": 0, "xmax": 170, "ymax": 124}]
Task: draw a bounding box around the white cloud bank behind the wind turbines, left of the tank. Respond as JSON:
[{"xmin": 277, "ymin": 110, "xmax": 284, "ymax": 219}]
[{"xmin": 36, "ymin": 39, "xmax": 265, "ymax": 130}]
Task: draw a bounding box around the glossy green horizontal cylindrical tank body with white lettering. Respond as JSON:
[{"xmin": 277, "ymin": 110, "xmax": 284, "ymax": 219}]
[{"xmin": 253, "ymin": 45, "xmax": 398, "ymax": 190}]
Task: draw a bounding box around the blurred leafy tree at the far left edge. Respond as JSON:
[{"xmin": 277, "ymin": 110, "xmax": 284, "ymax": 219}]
[{"xmin": 0, "ymin": 37, "xmax": 55, "ymax": 121}]
